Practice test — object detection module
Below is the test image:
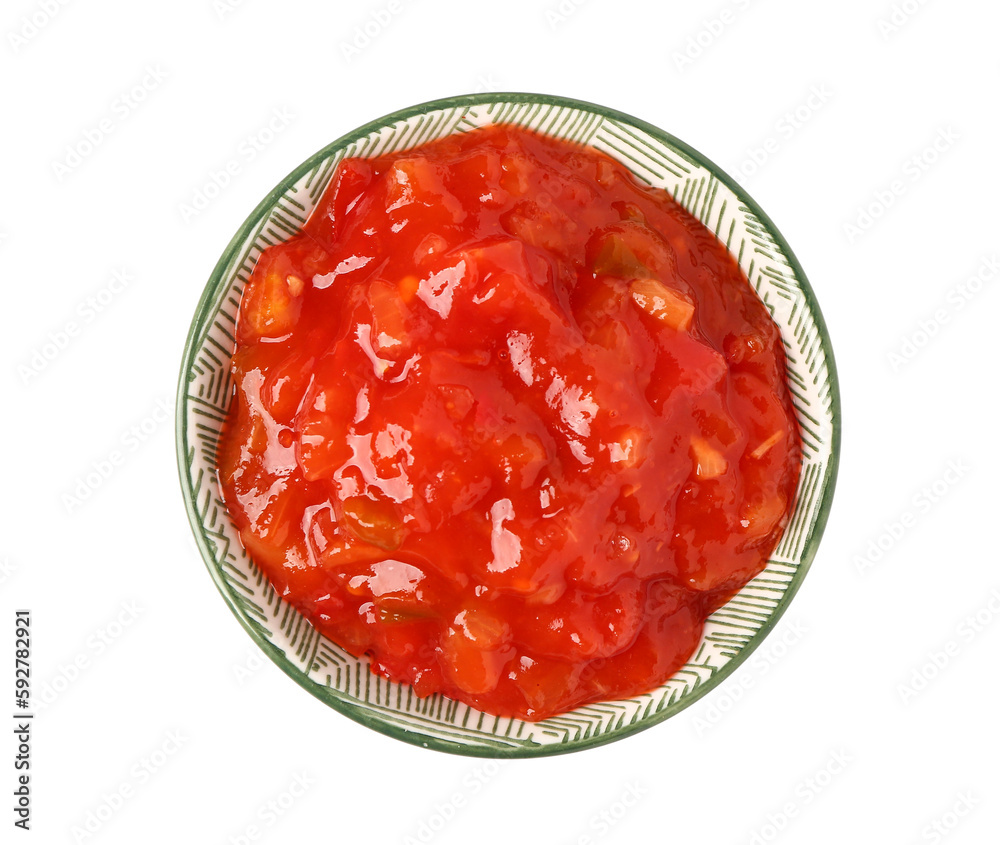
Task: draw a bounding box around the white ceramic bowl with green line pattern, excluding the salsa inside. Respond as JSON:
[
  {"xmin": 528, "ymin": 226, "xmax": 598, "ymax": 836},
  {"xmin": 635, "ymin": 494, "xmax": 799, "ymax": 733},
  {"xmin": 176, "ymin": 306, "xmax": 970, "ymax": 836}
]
[{"xmin": 176, "ymin": 93, "xmax": 840, "ymax": 757}]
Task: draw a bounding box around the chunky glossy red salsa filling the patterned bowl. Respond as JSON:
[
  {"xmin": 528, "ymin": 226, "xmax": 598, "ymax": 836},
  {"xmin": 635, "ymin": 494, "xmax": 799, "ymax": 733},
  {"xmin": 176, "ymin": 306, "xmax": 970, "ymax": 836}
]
[{"xmin": 219, "ymin": 126, "xmax": 800, "ymax": 720}]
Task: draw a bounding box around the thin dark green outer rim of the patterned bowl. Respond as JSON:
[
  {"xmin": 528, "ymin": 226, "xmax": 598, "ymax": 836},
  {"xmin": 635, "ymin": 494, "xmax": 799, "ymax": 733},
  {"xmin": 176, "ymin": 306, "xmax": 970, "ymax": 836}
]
[{"xmin": 175, "ymin": 92, "xmax": 842, "ymax": 759}]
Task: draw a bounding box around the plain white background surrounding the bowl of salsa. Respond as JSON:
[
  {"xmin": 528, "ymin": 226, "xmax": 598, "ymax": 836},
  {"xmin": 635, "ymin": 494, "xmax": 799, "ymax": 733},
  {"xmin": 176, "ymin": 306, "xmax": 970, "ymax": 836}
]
[{"xmin": 0, "ymin": 0, "xmax": 1000, "ymax": 845}]
